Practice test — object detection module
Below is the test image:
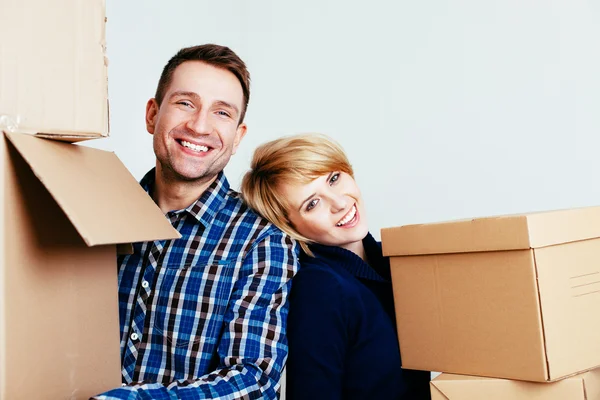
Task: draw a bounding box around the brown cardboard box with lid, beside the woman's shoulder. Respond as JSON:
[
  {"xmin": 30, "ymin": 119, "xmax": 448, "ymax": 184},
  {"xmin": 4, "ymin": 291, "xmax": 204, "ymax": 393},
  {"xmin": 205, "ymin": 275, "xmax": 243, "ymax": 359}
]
[{"xmin": 381, "ymin": 207, "xmax": 600, "ymax": 382}]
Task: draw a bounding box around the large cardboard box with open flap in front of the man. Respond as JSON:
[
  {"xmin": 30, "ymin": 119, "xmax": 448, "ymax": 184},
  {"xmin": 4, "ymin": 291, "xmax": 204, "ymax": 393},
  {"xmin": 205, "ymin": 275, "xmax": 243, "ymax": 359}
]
[{"xmin": 0, "ymin": 133, "xmax": 179, "ymax": 400}]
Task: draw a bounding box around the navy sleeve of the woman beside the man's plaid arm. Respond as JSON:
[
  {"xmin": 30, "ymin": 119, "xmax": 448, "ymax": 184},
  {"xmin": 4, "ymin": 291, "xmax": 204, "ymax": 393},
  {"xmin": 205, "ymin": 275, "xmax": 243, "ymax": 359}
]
[{"xmin": 286, "ymin": 268, "xmax": 356, "ymax": 400}]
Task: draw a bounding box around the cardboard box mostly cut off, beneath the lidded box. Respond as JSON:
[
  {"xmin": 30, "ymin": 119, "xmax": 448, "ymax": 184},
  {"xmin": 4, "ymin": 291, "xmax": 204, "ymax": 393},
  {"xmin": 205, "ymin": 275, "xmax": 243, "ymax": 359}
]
[{"xmin": 430, "ymin": 369, "xmax": 600, "ymax": 400}]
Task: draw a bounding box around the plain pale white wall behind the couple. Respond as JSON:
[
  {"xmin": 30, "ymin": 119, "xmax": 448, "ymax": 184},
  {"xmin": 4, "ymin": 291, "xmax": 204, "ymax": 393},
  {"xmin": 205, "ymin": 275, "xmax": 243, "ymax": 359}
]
[{"xmin": 90, "ymin": 0, "xmax": 600, "ymax": 237}]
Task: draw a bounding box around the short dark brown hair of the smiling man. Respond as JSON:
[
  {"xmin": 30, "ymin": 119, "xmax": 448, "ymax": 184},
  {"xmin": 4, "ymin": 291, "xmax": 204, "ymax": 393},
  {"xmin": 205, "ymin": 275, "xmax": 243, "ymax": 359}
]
[{"xmin": 154, "ymin": 44, "xmax": 250, "ymax": 124}]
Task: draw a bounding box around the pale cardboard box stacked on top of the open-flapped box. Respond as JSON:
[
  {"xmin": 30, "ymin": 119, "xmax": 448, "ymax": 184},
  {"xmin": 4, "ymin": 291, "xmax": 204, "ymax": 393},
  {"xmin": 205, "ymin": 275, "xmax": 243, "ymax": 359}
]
[{"xmin": 0, "ymin": 0, "xmax": 108, "ymax": 140}]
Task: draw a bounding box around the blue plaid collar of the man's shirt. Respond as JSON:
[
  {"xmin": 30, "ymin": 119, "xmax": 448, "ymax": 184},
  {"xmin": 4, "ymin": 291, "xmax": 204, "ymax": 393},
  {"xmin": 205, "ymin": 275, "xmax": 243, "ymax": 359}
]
[{"xmin": 140, "ymin": 168, "xmax": 229, "ymax": 228}]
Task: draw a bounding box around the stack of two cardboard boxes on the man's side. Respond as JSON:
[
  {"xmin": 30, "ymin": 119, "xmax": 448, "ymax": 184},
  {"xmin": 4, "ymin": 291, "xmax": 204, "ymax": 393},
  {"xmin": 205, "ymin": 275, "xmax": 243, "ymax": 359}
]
[{"xmin": 0, "ymin": 0, "xmax": 179, "ymax": 400}]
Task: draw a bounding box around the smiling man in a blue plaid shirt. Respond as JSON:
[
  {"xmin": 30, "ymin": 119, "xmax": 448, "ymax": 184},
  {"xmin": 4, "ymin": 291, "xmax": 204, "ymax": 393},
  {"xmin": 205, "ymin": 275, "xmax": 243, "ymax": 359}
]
[{"xmin": 97, "ymin": 45, "xmax": 297, "ymax": 399}]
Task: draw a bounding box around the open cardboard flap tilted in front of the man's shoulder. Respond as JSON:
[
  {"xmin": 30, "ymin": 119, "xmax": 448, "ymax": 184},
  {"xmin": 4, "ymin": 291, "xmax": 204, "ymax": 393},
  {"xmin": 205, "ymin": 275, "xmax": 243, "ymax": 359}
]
[{"xmin": 5, "ymin": 133, "xmax": 180, "ymax": 246}]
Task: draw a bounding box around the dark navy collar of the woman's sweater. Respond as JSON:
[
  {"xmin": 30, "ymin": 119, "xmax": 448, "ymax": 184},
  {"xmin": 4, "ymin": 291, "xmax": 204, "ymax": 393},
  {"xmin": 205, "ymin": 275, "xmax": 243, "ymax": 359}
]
[{"xmin": 303, "ymin": 233, "xmax": 390, "ymax": 282}]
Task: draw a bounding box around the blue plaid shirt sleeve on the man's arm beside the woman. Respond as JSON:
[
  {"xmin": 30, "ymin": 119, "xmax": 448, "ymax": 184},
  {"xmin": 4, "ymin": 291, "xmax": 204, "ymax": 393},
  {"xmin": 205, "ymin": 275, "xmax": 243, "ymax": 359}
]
[{"xmin": 93, "ymin": 233, "xmax": 298, "ymax": 400}]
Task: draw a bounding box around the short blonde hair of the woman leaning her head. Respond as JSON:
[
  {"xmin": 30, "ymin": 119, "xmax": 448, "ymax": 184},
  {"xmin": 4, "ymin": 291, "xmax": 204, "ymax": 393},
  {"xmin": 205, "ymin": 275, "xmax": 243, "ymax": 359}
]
[{"xmin": 242, "ymin": 134, "xmax": 354, "ymax": 255}]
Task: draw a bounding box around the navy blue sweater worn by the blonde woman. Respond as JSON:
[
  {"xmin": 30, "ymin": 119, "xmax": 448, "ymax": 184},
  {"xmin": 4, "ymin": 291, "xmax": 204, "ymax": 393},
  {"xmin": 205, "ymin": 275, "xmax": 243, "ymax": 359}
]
[{"xmin": 287, "ymin": 234, "xmax": 430, "ymax": 400}]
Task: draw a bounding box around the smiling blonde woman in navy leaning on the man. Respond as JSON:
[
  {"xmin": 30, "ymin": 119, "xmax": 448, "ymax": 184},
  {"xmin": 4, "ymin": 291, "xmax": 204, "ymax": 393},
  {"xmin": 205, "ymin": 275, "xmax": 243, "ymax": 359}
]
[{"xmin": 242, "ymin": 135, "xmax": 430, "ymax": 400}]
